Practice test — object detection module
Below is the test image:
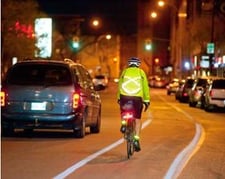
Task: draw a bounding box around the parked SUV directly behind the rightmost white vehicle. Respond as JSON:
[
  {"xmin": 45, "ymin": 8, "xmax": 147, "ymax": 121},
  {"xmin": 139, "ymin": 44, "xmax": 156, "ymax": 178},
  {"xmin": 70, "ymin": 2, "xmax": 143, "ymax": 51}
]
[{"xmin": 189, "ymin": 77, "xmax": 209, "ymax": 107}]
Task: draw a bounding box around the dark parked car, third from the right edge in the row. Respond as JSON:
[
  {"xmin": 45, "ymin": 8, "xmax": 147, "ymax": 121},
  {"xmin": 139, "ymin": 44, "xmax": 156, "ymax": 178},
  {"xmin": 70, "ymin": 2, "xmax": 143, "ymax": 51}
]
[{"xmin": 175, "ymin": 78, "xmax": 194, "ymax": 102}]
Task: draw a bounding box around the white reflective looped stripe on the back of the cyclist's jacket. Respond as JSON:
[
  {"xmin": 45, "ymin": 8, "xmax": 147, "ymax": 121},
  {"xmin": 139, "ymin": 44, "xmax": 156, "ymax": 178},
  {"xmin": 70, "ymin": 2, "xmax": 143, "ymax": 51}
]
[{"xmin": 121, "ymin": 76, "xmax": 141, "ymax": 94}]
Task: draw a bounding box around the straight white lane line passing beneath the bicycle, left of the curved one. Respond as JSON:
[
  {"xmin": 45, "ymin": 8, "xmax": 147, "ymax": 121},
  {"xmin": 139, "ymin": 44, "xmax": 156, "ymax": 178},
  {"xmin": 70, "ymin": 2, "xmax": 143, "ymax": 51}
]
[{"xmin": 54, "ymin": 119, "xmax": 151, "ymax": 179}]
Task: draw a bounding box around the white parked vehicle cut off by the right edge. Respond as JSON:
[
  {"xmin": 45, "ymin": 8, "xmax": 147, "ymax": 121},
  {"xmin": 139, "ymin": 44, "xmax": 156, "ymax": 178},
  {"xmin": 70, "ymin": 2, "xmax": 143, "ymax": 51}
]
[{"xmin": 202, "ymin": 78, "xmax": 225, "ymax": 111}]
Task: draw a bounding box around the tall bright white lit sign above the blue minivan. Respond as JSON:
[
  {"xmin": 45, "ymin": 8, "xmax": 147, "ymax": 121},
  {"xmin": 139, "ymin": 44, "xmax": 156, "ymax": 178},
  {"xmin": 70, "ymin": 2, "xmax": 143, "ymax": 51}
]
[{"xmin": 34, "ymin": 18, "xmax": 52, "ymax": 58}]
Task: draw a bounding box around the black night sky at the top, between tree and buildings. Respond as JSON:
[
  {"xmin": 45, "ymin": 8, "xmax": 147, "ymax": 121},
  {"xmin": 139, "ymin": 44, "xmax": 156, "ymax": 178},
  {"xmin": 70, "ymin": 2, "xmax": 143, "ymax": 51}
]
[{"xmin": 38, "ymin": 0, "xmax": 137, "ymax": 33}]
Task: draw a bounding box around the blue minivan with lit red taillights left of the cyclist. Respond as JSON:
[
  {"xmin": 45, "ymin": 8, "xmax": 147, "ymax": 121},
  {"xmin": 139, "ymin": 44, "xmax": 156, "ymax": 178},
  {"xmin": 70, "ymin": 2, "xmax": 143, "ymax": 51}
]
[{"xmin": 1, "ymin": 59, "xmax": 101, "ymax": 138}]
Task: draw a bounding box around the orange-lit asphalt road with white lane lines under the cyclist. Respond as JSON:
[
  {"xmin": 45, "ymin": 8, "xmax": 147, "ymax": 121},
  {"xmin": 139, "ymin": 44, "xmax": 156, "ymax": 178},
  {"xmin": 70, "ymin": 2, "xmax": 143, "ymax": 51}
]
[{"xmin": 1, "ymin": 84, "xmax": 225, "ymax": 179}]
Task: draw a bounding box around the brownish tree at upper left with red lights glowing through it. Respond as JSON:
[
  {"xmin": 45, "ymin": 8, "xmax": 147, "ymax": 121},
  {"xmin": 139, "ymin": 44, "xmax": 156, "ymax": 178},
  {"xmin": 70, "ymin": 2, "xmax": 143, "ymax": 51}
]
[{"xmin": 1, "ymin": 0, "xmax": 43, "ymax": 76}]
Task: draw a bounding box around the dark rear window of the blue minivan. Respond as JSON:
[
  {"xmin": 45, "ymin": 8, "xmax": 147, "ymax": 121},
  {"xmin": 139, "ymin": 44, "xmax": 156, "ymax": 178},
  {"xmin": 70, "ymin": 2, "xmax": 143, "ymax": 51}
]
[{"xmin": 6, "ymin": 64, "xmax": 72, "ymax": 86}]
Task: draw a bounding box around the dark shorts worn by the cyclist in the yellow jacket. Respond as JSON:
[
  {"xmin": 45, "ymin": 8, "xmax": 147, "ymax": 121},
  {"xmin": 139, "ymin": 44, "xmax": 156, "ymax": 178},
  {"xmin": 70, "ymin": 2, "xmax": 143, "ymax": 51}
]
[{"xmin": 120, "ymin": 95, "xmax": 143, "ymax": 119}]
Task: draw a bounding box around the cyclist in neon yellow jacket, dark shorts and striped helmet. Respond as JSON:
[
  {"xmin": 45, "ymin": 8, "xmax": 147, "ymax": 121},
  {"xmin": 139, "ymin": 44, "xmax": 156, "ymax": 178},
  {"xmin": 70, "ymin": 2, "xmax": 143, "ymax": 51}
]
[{"xmin": 117, "ymin": 57, "xmax": 150, "ymax": 152}]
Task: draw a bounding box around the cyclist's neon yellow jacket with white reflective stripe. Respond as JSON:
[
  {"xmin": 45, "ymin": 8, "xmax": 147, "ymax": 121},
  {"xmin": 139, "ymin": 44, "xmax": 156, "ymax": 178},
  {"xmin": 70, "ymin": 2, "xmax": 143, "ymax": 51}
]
[{"xmin": 117, "ymin": 67, "xmax": 150, "ymax": 102}]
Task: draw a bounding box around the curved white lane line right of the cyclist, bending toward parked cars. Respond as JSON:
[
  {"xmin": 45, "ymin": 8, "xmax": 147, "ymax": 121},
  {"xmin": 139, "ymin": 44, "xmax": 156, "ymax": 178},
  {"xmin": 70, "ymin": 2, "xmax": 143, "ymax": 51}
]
[{"xmin": 156, "ymin": 96, "xmax": 205, "ymax": 179}]
